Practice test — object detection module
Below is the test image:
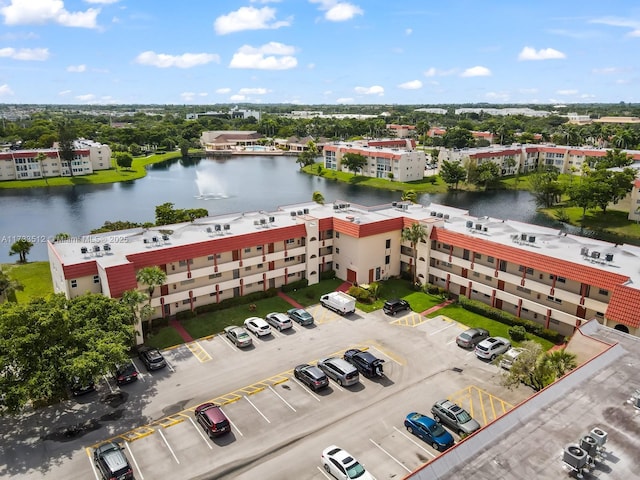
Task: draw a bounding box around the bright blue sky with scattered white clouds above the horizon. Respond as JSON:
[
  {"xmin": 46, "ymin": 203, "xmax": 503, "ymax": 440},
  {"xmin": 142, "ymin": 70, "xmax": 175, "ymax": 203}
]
[{"xmin": 0, "ymin": 0, "xmax": 640, "ymax": 104}]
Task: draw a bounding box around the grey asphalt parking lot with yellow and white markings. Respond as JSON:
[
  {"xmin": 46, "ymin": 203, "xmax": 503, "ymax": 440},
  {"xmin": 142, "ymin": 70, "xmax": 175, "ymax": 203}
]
[{"xmin": 0, "ymin": 306, "xmax": 530, "ymax": 480}]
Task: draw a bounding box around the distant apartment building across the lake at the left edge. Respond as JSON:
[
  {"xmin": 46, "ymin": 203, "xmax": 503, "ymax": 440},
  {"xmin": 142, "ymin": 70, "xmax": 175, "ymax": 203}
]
[{"xmin": 0, "ymin": 139, "xmax": 111, "ymax": 181}]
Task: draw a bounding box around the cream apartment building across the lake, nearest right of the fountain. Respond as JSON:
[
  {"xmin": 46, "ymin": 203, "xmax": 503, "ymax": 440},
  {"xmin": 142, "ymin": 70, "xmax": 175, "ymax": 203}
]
[{"xmin": 323, "ymin": 139, "xmax": 426, "ymax": 182}]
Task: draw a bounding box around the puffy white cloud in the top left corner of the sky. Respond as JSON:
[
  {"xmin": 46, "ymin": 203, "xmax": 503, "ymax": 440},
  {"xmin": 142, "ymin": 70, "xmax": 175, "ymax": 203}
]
[{"xmin": 0, "ymin": 0, "xmax": 100, "ymax": 28}]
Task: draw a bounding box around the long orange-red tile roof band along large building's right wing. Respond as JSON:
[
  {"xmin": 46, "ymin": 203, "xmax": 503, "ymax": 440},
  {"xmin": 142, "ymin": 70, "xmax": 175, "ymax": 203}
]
[{"xmin": 431, "ymin": 228, "xmax": 629, "ymax": 291}]
